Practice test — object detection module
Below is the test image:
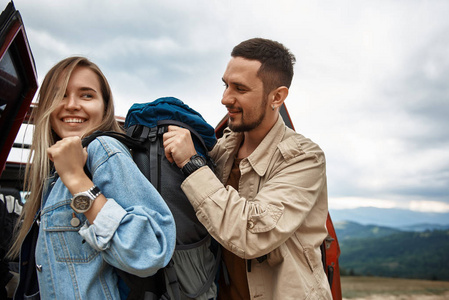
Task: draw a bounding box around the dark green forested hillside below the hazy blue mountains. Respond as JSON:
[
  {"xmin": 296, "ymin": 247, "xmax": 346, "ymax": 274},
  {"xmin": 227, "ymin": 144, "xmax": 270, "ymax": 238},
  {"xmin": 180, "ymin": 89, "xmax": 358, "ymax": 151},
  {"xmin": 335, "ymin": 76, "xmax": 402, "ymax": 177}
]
[{"xmin": 339, "ymin": 230, "xmax": 449, "ymax": 280}]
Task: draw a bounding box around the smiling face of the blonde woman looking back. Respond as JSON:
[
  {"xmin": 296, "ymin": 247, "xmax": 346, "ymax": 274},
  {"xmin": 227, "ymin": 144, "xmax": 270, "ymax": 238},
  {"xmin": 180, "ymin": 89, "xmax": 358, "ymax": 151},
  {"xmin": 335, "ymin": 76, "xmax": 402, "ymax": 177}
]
[{"xmin": 50, "ymin": 67, "xmax": 104, "ymax": 138}]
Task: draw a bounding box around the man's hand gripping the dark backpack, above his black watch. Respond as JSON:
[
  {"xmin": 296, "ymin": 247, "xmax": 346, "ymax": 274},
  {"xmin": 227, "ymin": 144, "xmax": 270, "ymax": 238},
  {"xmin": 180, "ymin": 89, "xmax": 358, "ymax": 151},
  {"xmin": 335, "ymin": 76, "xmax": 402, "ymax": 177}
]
[{"xmin": 163, "ymin": 125, "xmax": 196, "ymax": 168}]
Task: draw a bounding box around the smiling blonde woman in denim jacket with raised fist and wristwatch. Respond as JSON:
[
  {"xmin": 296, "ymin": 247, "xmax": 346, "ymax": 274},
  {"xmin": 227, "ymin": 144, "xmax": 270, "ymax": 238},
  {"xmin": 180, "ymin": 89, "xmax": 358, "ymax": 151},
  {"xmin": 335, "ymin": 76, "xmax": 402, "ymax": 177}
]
[{"xmin": 11, "ymin": 57, "xmax": 175, "ymax": 300}]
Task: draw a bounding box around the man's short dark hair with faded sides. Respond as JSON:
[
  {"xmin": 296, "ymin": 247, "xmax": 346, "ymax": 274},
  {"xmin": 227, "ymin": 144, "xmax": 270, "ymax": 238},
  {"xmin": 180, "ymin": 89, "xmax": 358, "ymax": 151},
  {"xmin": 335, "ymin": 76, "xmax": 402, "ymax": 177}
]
[{"xmin": 231, "ymin": 38, "xmax": 296, "ymax": 95}]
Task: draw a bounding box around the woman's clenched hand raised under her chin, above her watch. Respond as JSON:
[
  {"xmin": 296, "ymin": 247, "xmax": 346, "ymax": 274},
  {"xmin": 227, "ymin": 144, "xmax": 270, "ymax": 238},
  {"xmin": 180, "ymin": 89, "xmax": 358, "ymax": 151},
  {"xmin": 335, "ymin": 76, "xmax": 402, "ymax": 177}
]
[{"xmin": 47, "ymin": 136, "xmax": 90, "ymax": 194}]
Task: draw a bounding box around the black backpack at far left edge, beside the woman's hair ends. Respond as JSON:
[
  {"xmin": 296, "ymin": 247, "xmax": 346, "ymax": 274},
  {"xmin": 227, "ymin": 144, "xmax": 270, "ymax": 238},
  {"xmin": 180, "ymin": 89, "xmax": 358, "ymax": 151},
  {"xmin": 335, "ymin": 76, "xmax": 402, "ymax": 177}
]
[{"xmin": 0, "ymin": 188, "xmax": 23, "ymax": 299}]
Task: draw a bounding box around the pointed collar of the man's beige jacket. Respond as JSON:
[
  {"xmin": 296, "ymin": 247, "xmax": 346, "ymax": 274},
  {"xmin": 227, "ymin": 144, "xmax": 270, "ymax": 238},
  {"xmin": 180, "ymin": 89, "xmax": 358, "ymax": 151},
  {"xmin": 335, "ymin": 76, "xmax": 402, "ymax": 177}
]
[{"xmin": 226, "ymin": 115, "xmax": 285, "ymax": 176}]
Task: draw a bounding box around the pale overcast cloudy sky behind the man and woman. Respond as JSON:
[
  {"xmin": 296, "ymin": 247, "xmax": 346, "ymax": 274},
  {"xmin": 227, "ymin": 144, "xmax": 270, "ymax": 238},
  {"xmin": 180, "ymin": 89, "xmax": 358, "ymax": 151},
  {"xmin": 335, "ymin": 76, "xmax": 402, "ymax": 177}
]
[{"xmin": 0, "ymin": 0, "xmax": 449, "ymax": 219}]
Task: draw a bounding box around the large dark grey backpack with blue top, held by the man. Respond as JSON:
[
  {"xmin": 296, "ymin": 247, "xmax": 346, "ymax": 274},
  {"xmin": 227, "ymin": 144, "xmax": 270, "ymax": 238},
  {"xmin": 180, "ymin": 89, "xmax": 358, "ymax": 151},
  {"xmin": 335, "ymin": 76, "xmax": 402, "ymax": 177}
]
[{"xmin": 83, "ymin": 97, "xmax": 221, "ymax": 300}]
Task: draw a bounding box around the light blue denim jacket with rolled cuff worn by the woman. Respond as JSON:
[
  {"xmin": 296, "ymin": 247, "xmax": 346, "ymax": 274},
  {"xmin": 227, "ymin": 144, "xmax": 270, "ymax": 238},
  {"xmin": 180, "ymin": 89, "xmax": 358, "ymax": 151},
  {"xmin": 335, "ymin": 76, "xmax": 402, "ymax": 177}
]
[{"xmin": 24, "ymin": 137, "xmax": 176, "ymax": 300}]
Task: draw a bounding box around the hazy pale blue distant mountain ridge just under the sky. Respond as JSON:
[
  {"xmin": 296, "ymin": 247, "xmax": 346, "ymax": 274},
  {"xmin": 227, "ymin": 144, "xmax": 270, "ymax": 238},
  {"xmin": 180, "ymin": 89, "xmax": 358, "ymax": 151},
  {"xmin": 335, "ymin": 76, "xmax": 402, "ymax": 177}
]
[{"xmin": 329, "ymin": 207, "xmax": 449, "ymax": 228}]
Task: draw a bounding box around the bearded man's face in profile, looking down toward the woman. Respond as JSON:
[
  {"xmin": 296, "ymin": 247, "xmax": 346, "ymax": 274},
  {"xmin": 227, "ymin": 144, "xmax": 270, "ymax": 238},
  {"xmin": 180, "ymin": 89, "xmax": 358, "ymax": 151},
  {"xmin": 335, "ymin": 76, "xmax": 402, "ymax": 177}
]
[{"xmin": 221, "ymin": 57, "xmax": 268, "ymax": 132}]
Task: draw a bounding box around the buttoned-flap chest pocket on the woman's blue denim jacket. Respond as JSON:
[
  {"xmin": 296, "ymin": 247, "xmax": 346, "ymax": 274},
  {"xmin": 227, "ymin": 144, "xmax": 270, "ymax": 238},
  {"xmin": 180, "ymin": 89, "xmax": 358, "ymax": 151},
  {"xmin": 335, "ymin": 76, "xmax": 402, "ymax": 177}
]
[{"xmin": 41, "ymin": 200, "xmax": 98, "ymax": 263}]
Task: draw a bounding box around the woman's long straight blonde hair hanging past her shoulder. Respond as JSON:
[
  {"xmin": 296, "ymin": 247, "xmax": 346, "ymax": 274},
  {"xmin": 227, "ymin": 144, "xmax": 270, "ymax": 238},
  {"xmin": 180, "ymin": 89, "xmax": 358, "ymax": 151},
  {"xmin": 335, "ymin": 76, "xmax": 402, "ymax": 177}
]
[{"xmin": 8, "ymin": 57, "xmax": 122, "ymax": 257}]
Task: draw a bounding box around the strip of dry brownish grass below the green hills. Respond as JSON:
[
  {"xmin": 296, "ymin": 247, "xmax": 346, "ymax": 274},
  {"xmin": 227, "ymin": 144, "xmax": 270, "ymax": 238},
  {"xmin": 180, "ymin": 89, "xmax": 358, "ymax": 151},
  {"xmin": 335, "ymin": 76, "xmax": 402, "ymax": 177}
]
[{"xmin": 341, "ymin": 276, "xmax": 449, "ymax": 299}]
